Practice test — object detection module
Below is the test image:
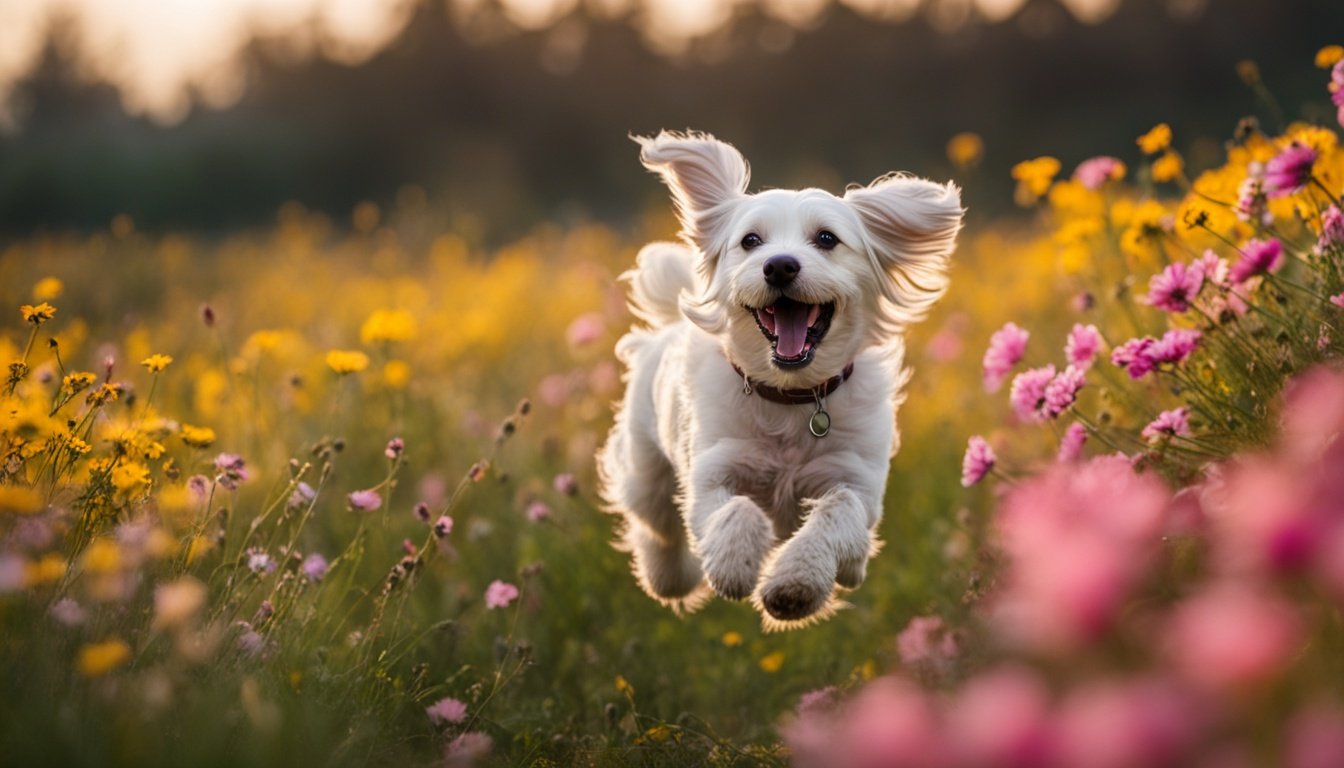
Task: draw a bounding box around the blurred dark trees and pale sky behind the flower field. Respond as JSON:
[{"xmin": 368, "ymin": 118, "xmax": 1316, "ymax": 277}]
[{"xmin": 0, "ymin": 0, "xmax": 1344, "ymax": 239}]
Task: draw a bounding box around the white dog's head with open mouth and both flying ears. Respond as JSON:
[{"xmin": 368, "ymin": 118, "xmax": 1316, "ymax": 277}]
[{"xmin": 636, "ymin": 132, "xmax": 962, "ymax": 387}]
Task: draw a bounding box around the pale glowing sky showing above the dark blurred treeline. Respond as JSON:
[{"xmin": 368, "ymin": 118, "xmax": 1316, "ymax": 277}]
[{"xmin": 0, "ymin": 0, "xmax": 1120, "ymax": 122}]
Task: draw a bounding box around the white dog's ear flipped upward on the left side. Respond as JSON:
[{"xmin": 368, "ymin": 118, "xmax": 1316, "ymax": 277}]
[{"xmin": 630, "ymin": 130, "xmax": 751, "ymax": 252}]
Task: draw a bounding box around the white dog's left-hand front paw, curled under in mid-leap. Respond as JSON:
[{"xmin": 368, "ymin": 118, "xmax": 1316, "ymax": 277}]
[{"xmin": 699, "ymin": 496, "xmax": 774, "ymax": 600}]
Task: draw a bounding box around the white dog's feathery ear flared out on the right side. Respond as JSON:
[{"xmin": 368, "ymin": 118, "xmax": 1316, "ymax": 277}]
[{"xmin": 844, "ymin": 175, "xmax": 965, "ymax": 324}]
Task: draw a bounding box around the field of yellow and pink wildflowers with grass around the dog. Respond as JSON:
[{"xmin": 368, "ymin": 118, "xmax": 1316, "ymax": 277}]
[{"xmin": 0, "ymin": 47, "xmax": 1344, "ymax": 768}]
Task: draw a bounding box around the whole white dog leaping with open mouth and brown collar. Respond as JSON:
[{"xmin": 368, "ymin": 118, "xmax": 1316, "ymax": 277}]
[{"xmin": 598, "ymin": 132, "xmax": 962, "ymax": 628}]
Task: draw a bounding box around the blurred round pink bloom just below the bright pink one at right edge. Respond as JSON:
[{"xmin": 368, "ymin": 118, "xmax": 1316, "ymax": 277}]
[{"xmin": 1163, "ymin": 582, "xmax": 1302, "ymax": 689}]
